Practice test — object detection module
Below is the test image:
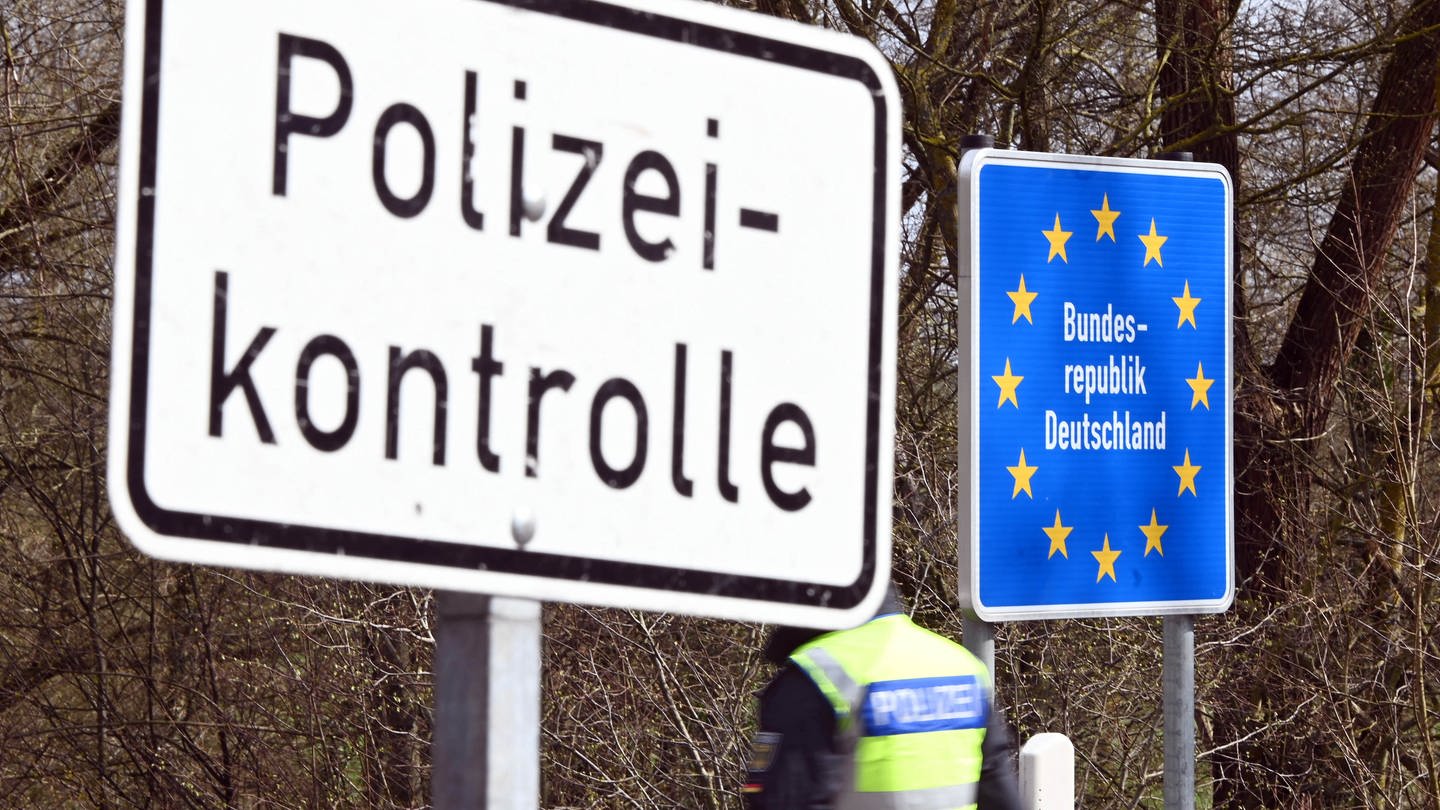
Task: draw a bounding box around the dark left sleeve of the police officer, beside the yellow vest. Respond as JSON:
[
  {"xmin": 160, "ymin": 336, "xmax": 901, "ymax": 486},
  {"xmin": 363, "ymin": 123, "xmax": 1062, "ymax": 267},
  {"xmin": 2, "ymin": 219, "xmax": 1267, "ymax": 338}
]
[{"xmin": 744, "ymin": 664, "xmax": 841, "ymax": 810}]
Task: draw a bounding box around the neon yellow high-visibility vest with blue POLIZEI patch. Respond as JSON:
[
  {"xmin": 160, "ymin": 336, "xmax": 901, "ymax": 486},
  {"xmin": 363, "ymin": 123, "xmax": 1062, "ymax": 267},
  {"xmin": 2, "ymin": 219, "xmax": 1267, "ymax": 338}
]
[{"xmin": 791, "ymin": 615, "xmax": 989, "ymax": 810}]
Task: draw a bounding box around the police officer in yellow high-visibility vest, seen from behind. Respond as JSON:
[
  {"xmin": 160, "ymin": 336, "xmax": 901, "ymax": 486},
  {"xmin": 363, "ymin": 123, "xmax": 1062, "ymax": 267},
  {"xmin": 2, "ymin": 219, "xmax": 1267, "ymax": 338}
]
[{"xmin": 743, "ymin": 585, "xmax": 1020, "ymax": 810}]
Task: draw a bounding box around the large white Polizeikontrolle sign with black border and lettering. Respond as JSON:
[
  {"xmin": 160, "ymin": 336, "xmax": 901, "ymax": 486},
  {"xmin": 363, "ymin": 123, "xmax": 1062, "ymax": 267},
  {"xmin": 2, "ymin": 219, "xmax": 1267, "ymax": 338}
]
[{"xmin": 109, "ymin": 0, "xmax": 900, "ymax": 626}]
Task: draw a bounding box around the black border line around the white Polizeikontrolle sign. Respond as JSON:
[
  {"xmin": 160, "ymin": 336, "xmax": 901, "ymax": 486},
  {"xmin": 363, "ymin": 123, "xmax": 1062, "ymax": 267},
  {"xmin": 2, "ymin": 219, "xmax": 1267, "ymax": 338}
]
[{"xmin": 125, "ymin": 0, "xmax": 890, "ymax": 610}]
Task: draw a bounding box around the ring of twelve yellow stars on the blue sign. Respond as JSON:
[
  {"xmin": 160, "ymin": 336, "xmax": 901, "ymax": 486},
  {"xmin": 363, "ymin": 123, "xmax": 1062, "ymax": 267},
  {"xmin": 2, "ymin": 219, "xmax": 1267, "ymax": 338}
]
[{"xmin": 991, "ymin": 193, "xmax": 1215, "ymax": 584}]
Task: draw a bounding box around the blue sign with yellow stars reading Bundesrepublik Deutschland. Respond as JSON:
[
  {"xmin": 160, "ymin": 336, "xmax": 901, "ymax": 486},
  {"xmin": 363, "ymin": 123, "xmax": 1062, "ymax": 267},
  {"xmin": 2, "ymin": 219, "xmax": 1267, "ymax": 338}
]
[{"xmin": 959, "ymin": 150, "xmax": 1234, "ymax": 621}]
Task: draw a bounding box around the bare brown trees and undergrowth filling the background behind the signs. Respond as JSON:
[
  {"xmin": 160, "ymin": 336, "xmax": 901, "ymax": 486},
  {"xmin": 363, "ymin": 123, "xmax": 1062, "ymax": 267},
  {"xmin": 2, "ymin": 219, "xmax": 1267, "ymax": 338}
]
[{"xmin": 0, "ymin": 0, "xmax": 1440, "ymax": 809}]
